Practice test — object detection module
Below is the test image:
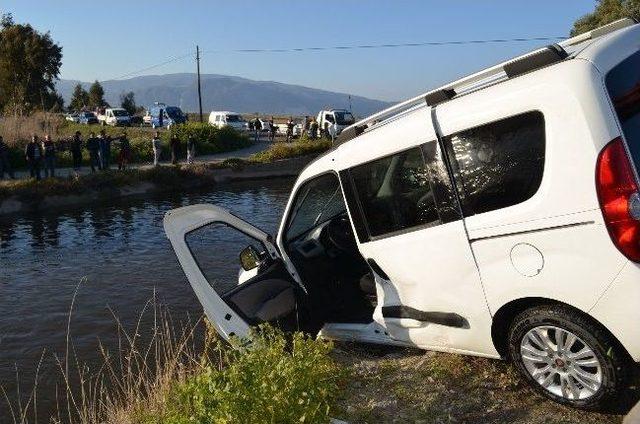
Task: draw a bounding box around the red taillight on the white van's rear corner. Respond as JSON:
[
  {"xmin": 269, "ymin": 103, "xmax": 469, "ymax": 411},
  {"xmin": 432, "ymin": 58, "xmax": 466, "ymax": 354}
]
[{"xmin": 596, "ymin": 138, "xmax": 640, "ymax": 262}]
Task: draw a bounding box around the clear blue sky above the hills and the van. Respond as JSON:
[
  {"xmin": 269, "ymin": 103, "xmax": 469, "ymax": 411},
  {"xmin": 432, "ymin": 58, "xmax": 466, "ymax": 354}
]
[{"xmin": 0, "ymin": 0, "xmax": 595, "ymax": 100}]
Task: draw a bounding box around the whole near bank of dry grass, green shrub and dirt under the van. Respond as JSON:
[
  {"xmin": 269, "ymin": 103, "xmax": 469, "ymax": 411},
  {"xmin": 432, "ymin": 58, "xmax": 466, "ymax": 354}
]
[{"xmin": 0, "ymin": 283, "xmax": 637, "ymax": 424}]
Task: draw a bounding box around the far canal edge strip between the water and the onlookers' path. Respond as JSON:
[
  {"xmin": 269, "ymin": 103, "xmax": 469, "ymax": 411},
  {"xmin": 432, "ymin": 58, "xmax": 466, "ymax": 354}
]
[{"xmin": 0, "ymin": 155, "xmax": 317, "ymax": 217}]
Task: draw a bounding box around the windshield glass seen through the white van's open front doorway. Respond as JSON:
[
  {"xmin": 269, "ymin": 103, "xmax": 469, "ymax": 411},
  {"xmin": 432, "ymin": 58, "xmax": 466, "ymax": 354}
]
[{"xmin": 286, "ymin": 174, "xmax": 346, "ymax": 241}]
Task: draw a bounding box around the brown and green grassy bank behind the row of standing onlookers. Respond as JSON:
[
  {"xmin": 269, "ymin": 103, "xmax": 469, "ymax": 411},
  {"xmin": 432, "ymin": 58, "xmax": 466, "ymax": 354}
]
[{"xmin": 0, "ymin": 113, "xmax": 251, "ymax": 169}]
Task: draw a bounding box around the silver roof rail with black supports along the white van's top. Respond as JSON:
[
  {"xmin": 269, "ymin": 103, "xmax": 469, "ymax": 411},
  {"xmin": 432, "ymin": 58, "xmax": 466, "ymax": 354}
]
[{"xmin": 336, "ymin": 18, "xmax": 636, "ymax": 145}]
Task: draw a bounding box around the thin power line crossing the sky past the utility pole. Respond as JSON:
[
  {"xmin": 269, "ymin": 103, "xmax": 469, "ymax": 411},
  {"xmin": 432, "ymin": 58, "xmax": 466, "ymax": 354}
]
[{"xmin": 106, "ymin": 37, "xmax": 567, "ymax": 80}]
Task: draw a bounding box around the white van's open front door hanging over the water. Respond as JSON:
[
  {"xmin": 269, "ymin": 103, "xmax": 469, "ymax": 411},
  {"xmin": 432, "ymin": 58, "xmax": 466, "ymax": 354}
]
[{"xmin": 164, "ymin": 205, "xmax": 299, "ymax": 339}]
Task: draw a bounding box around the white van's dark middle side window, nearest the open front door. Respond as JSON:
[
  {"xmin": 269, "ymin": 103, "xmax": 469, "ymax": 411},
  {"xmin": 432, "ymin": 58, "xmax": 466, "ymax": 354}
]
[{"xmin": 350, "ymin": 147, "xmax": 439, "ymax": 237}]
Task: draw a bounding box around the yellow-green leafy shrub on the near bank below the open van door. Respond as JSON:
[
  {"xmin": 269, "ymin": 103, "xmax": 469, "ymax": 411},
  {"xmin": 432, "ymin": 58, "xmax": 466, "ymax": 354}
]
[{"xmin": 155, "ymin": 326, "xmax": 341, "ymax": 424}]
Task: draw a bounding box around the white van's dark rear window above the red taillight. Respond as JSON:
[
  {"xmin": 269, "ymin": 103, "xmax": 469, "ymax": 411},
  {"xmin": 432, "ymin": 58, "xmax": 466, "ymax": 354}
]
[{"xmin": 606, "ymin": 52, "xmax": 640, "ymax": 171}]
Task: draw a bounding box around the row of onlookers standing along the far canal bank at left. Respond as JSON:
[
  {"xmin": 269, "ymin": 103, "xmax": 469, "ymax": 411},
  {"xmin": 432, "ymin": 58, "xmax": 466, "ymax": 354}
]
[{"xmin": 0, "ymin": 130, "xmax": 196, "ymax": 180}]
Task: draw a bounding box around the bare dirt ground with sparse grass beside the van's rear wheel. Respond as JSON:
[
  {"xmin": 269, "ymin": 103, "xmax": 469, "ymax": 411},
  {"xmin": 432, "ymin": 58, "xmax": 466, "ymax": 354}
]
[{"xmin": 335, "ymin": 344, "xmax": 638, "ymax": 424}]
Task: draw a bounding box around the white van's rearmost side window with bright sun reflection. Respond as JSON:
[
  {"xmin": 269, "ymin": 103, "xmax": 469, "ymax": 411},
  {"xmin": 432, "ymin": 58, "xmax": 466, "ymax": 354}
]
[{"xmin": 444, "ymin": 111, "xmax": 545, "ymax": 216}]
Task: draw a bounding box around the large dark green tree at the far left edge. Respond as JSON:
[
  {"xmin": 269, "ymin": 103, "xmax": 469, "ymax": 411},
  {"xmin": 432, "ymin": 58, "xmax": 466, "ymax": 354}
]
[{"xmin": 0, "ymin": 14, "xmax": 62, "ymax": 115}]
